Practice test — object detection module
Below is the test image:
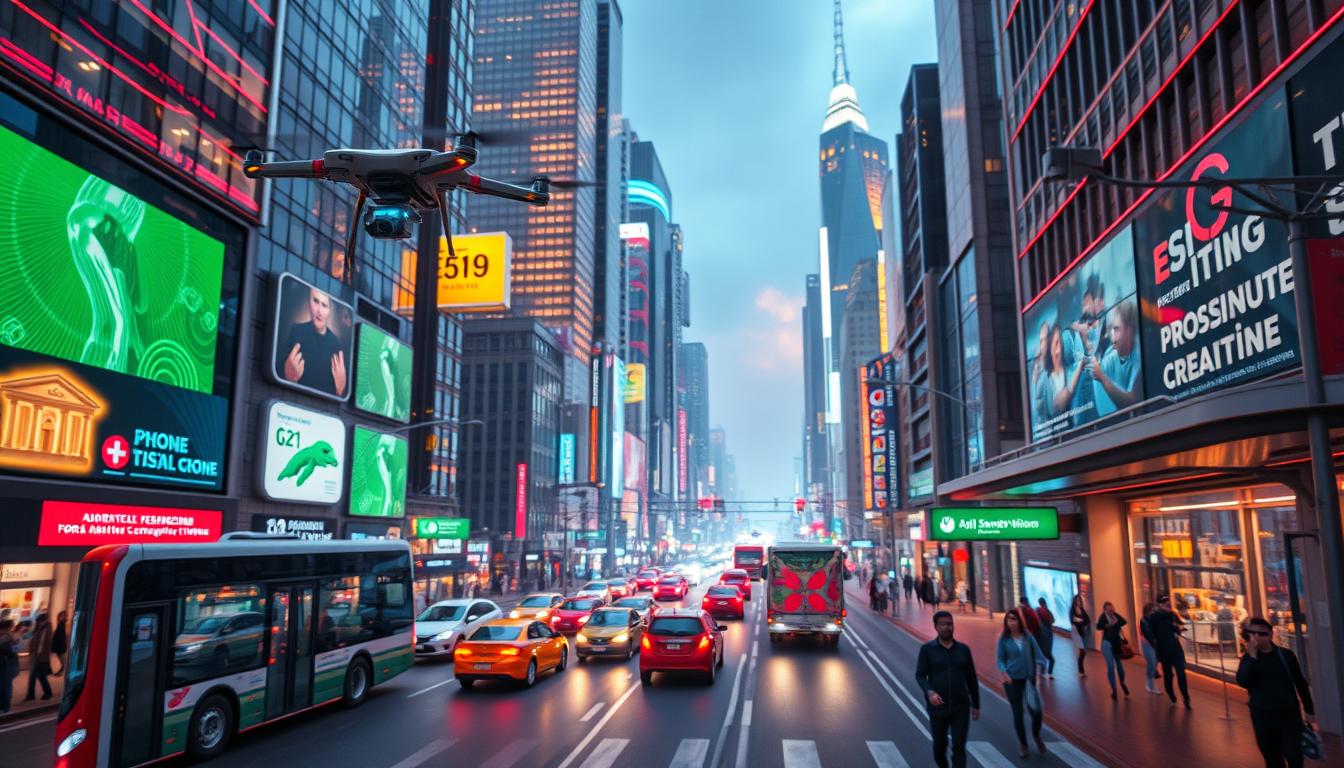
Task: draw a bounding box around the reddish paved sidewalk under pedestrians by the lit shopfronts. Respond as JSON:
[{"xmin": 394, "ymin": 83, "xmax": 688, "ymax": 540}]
[{"xmin": 852, "ymin": 593, "xmax": 1341, "ymax": 767}]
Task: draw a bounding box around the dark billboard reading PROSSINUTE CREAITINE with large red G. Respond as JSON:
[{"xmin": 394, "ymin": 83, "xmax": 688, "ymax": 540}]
[{"xmin": 1133, "ymin": 91, "xmax": 1300, "ymax": 399}]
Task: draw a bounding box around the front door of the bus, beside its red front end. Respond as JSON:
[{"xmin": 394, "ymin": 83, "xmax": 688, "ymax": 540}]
[{"xmin": 112, "ymin": 603, "xmax": 169, "ymax": 765}]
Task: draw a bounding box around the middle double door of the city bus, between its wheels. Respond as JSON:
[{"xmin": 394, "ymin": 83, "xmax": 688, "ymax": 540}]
[{"xmin": 266, "ymin": 584, "xmax": 314, "ymax": 720}]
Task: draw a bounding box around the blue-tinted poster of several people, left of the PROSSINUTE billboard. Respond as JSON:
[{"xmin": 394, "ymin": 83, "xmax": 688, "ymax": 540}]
[{"xmin": 1023, "ymin": 227, "xmax": 1144, "ymax": 440}]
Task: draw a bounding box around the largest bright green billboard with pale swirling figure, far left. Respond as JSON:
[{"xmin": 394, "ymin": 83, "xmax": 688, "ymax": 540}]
[{"xmin": 0, "ymin": 128, "xmax": 224, "ymax": 394}]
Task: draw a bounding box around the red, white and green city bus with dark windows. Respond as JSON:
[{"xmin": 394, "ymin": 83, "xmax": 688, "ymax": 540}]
[{"xmin": 55, "ymin": 534, "xmax": 414, "ymax": 768}]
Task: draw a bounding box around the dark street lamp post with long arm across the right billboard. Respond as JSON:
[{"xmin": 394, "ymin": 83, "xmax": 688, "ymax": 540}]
[{"xmin": 1042, "ymin": 147, "xmax": 1344, "ymax": 718}]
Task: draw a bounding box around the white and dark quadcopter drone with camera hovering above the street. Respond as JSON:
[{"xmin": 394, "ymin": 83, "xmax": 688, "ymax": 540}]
[{"xmin": 243, "ymin": 133, "xmax": 551, "ymax": 253}]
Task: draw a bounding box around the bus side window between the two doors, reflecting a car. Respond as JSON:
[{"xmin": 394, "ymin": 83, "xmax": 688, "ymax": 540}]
[{"xmin": 172, "ymin": 584, "xmax": 266, "ymax": 687}]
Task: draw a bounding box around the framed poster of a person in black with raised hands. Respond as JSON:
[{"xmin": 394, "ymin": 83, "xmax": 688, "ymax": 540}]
[{"xmin": 270, "ymin": 272, "xmax": 355, "ymax": 401}]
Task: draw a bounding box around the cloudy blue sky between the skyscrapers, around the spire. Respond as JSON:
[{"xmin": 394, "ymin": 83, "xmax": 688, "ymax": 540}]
[{"xmin": 621, "ymin": 0, "xmax": 937, "ymax": 500}]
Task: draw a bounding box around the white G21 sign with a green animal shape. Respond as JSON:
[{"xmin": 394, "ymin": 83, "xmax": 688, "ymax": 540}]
[{"xmin": 261, "ymin": 401, "xmax": 345, "ymax": 504}]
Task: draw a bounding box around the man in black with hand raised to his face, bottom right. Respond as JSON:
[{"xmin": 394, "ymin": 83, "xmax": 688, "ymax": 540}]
[{"xmin": 1236, "ymin": 616, "xmax": 1316, "ymax": 768}]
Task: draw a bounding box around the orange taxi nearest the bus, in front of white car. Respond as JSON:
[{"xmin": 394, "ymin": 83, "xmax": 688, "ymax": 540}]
[{"xmin": 453, "ymin": 619, "xmax": 570, "ymax": 690}]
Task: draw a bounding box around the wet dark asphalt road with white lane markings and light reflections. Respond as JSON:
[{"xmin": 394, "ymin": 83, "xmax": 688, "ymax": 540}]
[{"xmin": 0, "ymin": 582, "xmax": 1101, "ymax": 768}]
